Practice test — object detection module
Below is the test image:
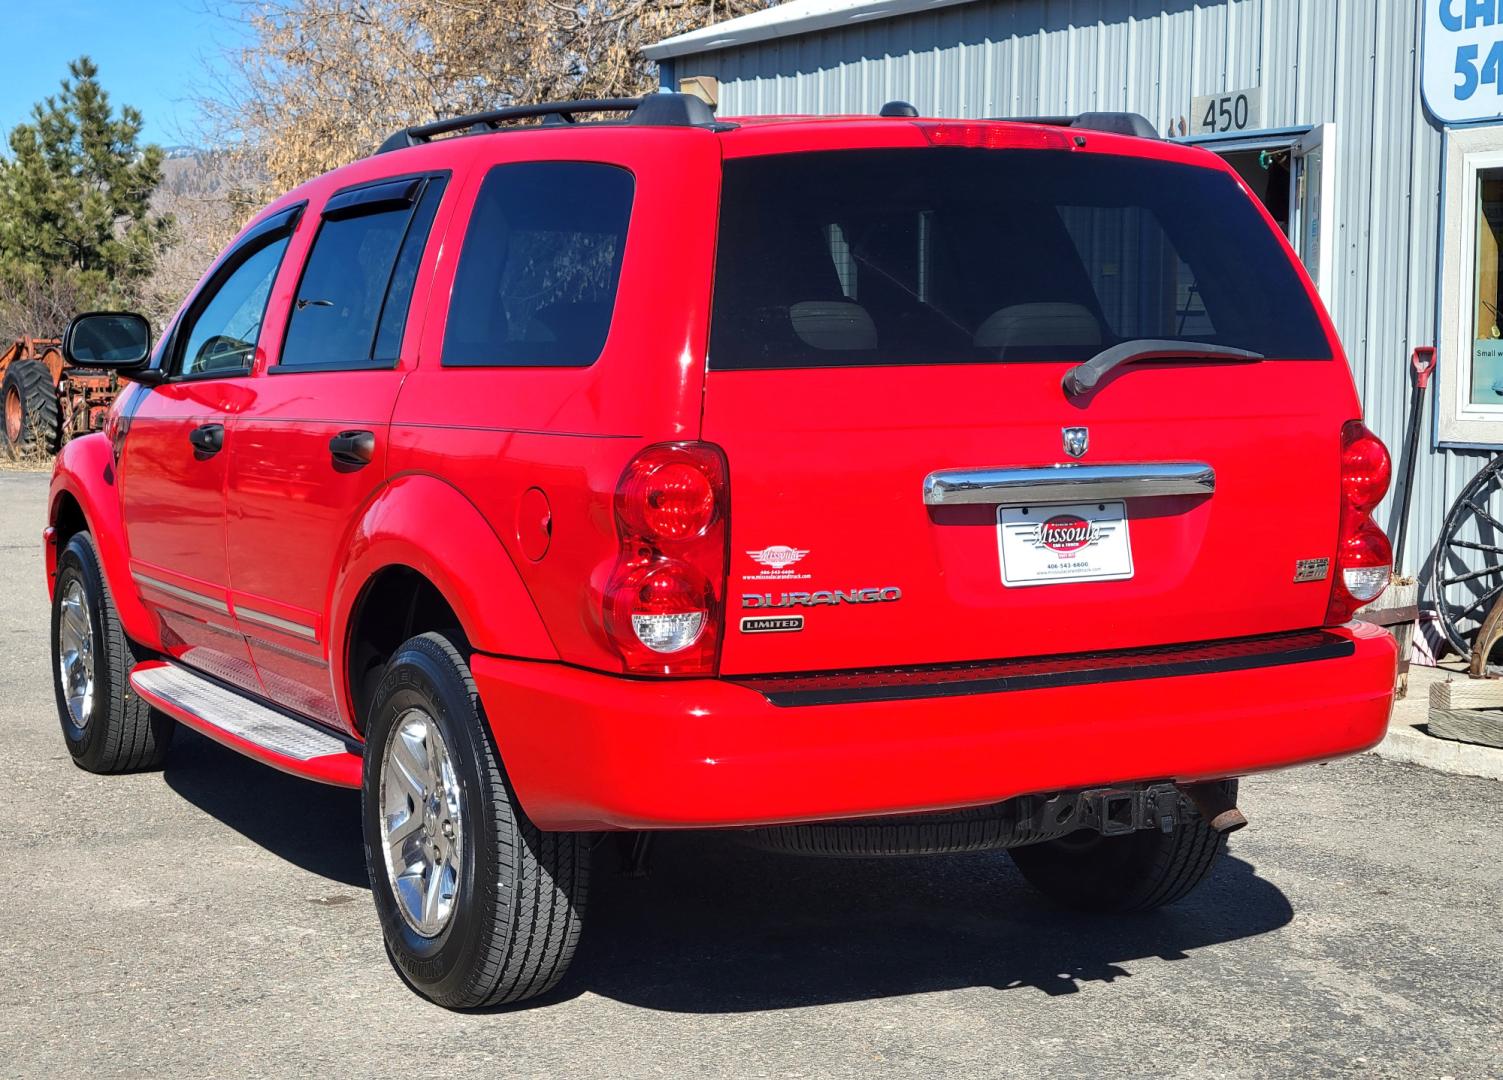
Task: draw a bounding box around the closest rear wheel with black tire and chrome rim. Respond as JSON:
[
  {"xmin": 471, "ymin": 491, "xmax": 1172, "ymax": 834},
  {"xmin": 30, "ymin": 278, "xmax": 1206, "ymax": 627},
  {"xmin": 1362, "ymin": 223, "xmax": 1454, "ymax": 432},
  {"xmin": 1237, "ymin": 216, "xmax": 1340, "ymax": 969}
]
[{"xmin": 362, "ymin": 634, "xmax": 589, "ymax": 1009}]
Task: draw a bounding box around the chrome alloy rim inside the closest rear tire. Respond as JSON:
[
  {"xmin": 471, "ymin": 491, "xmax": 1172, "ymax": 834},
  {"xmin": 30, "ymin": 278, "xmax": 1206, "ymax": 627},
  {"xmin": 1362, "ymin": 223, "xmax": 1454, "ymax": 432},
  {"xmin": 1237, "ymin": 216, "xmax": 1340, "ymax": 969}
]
[{"xmin": 380, "ymin": 709, "xmax": 464, "ymax": 937}]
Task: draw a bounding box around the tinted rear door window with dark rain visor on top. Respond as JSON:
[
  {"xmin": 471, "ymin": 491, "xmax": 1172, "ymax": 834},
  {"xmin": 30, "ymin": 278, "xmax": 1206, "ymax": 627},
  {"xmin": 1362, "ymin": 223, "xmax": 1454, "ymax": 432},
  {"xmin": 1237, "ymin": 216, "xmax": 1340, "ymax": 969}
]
[{"xmin": 280, "ymin": 177, "xmax": 443, "ymax": 371}]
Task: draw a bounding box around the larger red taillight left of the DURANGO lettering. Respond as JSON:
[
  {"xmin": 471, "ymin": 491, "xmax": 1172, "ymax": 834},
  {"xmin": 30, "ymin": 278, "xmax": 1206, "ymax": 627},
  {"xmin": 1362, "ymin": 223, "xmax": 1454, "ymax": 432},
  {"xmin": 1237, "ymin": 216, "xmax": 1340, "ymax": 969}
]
[{"xmin": 606, "ymin": 443, "xmax": 730, "ymax": 674}]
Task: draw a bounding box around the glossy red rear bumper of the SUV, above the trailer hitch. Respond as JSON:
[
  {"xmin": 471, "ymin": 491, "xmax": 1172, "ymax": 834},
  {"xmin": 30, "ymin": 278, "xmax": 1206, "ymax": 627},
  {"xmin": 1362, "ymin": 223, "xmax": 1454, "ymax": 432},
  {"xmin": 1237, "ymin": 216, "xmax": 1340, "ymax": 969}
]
[{"xmin": 472, "ymin": 623, "xmax": 1398, "ymax": 829}]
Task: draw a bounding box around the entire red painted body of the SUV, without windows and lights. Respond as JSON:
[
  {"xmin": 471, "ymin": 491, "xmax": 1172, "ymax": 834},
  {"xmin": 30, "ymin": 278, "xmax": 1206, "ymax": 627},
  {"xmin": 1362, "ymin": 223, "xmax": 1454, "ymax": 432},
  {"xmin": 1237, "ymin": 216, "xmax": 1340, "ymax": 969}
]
[{"xmin": 51, "ymin": 117, "xmax": 1393, "ymax": 829}]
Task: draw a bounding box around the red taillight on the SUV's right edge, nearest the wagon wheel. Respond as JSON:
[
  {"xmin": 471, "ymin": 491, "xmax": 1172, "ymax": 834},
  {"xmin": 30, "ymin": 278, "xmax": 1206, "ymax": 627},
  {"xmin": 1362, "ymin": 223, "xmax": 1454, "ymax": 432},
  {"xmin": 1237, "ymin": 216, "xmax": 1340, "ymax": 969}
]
[{"xmin": 1326, "ymin": 421, "xmax": 1393, "ymax": 626}]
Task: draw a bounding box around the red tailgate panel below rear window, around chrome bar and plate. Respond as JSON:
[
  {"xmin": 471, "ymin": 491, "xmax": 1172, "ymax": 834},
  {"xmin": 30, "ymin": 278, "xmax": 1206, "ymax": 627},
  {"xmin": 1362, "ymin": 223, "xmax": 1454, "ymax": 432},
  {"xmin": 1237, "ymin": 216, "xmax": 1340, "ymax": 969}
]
[{"xmin": 705, "ymin": 361, "xmax": 1359, "ymax": 674}]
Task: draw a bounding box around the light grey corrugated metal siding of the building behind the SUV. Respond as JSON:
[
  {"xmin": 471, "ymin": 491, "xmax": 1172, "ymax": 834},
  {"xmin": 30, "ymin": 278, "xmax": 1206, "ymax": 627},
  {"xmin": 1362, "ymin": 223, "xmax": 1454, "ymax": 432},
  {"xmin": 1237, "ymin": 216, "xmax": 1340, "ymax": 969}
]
[{"xmin": 673, "ymin": 0, "xmax": 1486, "ymax": 582}]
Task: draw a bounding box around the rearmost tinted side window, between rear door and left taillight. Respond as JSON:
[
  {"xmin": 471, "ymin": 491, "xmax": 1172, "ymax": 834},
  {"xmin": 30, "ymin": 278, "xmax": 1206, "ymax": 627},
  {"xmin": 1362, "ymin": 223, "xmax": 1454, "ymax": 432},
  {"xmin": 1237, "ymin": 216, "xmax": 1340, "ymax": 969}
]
[{"xmin": 443, "ymin": 161, "xmax": 634, "ymax": 367}]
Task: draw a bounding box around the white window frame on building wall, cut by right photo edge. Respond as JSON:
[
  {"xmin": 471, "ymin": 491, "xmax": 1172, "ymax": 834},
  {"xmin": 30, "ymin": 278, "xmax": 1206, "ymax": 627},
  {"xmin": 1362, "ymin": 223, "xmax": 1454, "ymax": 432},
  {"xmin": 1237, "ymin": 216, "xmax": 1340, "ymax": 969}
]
[{"xmin": 1435, "ymin": 126, "xmax": 1503, "ymax": 448}]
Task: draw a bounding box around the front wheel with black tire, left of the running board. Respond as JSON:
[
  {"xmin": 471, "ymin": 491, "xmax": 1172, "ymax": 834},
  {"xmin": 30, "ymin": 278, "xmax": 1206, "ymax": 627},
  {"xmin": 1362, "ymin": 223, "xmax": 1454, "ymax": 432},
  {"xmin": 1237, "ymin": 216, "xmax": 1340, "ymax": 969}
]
[{"xmin": 53, "ymin": 533, "xmax": 176, "ymax": 772}]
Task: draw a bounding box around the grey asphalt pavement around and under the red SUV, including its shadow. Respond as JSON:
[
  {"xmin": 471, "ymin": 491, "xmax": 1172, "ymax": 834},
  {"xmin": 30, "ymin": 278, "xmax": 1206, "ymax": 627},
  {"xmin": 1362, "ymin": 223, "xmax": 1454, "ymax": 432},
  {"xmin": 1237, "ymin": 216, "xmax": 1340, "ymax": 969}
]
[{"xmin": 0, "ymin": 472, "xmax": 1503, "ymax": 1080}]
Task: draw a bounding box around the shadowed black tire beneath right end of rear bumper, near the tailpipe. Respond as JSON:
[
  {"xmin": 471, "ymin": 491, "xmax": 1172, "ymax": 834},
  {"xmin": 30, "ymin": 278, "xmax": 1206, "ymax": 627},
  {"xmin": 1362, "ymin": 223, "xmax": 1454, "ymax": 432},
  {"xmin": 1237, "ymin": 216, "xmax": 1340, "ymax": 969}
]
[{"xmin": 1009, "ymin": 780, "xmax": 1237, "ymax": 912}]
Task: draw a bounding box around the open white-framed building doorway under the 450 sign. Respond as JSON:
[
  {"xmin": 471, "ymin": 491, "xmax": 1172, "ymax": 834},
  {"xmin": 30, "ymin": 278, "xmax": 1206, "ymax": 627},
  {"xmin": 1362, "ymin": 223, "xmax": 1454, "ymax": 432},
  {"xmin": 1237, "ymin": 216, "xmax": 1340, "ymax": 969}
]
[{"xmin": 1178, "ymin": 123, "xmax": 1336, "ymax": 309}]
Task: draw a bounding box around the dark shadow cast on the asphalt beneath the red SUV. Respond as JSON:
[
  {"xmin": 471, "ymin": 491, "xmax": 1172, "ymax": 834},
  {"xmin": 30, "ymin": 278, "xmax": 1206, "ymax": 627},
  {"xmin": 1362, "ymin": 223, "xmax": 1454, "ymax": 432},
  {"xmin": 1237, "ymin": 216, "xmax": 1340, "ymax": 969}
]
[{"xmin": 165, "ymin": 729, "xmax": 1294, "ymax": 1012}]
